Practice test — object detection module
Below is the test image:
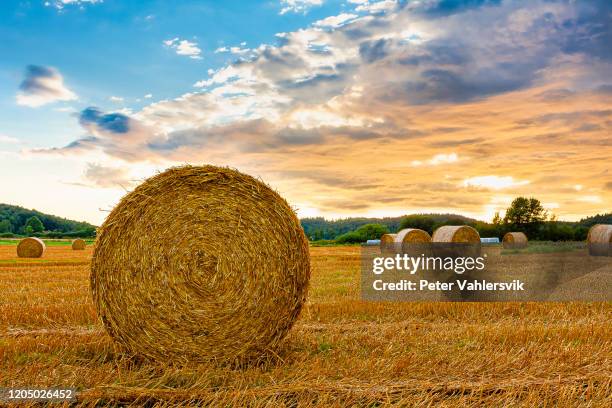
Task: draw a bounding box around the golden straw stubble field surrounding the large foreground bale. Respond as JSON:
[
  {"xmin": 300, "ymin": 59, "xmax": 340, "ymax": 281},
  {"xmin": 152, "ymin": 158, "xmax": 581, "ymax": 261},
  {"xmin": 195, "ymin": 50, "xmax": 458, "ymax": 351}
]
[{"xmin": 0, "ymin": 246, "xmax": 612, "ymax": 406}]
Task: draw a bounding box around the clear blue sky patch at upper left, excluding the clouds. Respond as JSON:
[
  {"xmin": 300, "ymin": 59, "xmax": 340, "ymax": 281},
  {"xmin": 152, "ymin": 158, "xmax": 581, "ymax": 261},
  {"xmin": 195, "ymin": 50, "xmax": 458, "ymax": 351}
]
[{"xmin": 0, "ymin": 0, "xmax": 350, "ymax": 146}]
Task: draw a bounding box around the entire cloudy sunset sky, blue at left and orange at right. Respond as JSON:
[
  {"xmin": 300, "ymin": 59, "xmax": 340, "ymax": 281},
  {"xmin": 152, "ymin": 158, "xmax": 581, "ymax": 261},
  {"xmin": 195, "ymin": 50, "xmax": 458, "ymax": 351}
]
[{"xmin": 0, "ymin": 0, "xmax": 612, "ymax": 224}]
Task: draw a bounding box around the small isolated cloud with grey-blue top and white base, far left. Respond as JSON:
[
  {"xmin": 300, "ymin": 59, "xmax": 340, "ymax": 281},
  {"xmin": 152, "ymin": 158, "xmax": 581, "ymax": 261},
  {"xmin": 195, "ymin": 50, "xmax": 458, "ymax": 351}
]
[{"xmin": 16, "ymin": 65, "xmax": 77, "ymax": 108}]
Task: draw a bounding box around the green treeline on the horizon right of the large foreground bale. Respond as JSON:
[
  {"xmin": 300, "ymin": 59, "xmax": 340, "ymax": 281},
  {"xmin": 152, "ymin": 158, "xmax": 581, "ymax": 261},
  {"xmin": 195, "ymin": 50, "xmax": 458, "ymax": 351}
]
[{"xmin": 302, "ymin": 197, "xmax": 612, "ymax": 243}]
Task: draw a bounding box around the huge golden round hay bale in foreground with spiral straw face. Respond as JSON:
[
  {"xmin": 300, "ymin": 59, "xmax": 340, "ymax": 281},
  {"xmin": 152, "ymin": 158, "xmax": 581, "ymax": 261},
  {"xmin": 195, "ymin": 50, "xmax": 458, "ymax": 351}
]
[{"xmin": 91, "ymin": 166, "xmax": 310, "ymax": 362}]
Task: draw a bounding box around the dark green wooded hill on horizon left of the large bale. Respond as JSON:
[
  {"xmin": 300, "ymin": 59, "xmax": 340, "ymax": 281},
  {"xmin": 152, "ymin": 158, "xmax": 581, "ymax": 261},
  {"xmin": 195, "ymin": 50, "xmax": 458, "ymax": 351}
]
[{"xmin": 0, "ymin": 204, "xmax": 96, "ymax": 238}]
